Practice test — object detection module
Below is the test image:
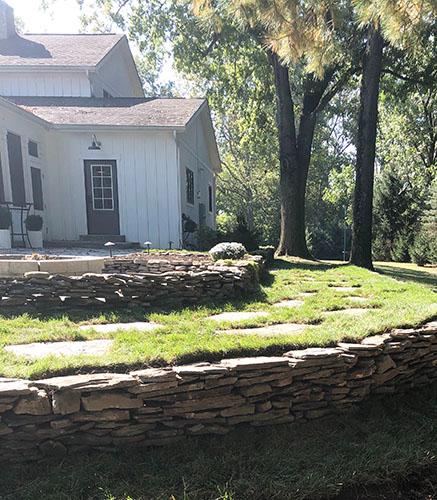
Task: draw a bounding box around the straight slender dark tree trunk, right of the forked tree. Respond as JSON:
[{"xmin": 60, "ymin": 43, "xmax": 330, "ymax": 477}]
[{"xmin": 350, "ymin": 28, "xmax": 384, "ymax": 269}]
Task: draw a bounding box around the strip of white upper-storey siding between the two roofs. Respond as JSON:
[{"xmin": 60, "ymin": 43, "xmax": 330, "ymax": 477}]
[{"xmin": 0, "ymin": 71, "xmax": 91, "ymax": 97}]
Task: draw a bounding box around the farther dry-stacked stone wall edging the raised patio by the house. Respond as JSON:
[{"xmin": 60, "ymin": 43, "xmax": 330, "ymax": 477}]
[{"xmin": 0, "ymin": 258, "xmax": 262, "ymax": 308}]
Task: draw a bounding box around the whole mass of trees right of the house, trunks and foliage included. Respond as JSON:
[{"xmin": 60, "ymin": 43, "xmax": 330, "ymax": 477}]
[{"xmin": 53, "ymin": 0, "xmax": 437, "ymax": 267}]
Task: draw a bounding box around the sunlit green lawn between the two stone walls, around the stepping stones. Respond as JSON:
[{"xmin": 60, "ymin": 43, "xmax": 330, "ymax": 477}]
[{"xmin": 0, "ymin": 260, "xmax": 437, "ymax": 378}]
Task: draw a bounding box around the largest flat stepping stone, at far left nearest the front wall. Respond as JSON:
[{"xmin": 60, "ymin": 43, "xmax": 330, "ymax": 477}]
[{"xmin": 4, "ymin": 339, "xmax": 113, "ymax": 359}]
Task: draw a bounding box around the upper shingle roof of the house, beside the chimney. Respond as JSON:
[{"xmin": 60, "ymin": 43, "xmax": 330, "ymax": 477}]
[{"xmin": 0, "ymin": 34, "xmax": 123, "ymax": 69}]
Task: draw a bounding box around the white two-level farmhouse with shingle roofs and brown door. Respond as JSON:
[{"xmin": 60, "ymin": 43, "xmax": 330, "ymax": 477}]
[{"xmin": 0, "ymin": 0, "xmax": 220, "ymax": 248}]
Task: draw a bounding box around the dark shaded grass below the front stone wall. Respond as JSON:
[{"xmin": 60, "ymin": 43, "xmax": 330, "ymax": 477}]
[{"xmin": 0, "ymin": 386, "xmax": 437, "ymax": 500}]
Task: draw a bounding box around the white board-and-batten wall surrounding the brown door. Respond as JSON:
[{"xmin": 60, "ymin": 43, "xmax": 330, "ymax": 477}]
[{"xmin": 45, "ymin": 130, "xmax": 181, "ymax": 248}]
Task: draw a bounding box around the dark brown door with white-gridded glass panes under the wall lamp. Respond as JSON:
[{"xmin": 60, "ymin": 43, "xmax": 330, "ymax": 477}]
[{"xmin": 85, "ymin": 160, "xmax": 120, "ymax": 235}]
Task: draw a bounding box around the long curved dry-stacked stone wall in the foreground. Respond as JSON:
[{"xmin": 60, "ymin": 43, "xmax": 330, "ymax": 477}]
[{"xmin": 0, "ymin": 322, "xmax": 437, "ymax": 460}]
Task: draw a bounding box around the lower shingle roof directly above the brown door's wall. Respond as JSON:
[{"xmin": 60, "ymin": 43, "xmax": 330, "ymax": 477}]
[{"xmin": 5, "ymin": 97, "xmax": 205, "ymax": 128}]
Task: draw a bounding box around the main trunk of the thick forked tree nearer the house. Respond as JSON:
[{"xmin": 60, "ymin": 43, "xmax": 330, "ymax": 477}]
[{"xmin": 270, "ymin": 53, "xmax": 311, "ymax": 259}]
